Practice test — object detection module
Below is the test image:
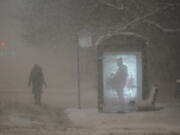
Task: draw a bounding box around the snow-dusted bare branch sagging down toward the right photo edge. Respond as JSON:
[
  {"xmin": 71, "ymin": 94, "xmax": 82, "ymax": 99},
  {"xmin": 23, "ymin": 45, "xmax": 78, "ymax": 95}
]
[{"xmin": 143, "ymin": 20, "xmax": 180, "ymax": 32}]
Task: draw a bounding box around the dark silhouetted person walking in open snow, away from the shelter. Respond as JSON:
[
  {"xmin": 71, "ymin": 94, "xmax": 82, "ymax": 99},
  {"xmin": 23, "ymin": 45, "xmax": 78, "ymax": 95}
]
[{"xmin": 28, "ymin": 64, "xmax": 47, "ymax": 105}]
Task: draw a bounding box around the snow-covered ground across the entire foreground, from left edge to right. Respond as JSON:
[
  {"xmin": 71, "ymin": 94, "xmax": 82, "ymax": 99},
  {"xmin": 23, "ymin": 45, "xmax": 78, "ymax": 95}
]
[{"xmin": 0, "ymin": 103, "xmax": 180, "ymax": 135}]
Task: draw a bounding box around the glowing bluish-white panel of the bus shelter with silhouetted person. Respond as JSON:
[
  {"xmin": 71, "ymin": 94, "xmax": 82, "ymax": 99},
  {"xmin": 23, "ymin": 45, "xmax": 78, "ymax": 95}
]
[{"xmin": 103, "ymin": 52, "xmax": 142, "ymax": 112}]
